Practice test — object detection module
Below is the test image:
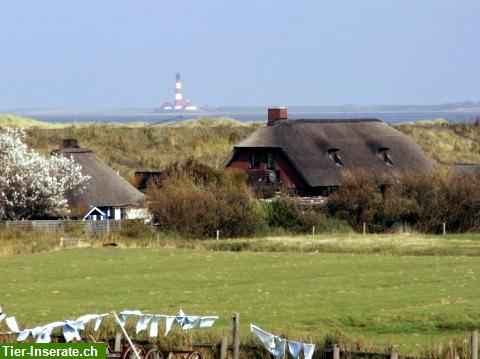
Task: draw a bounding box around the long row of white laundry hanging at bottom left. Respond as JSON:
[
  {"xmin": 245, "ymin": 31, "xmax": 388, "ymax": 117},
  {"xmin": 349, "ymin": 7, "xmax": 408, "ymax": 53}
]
[{"xmin": 0, "ymin": 309, "xmax": 218, "ymax": 343}]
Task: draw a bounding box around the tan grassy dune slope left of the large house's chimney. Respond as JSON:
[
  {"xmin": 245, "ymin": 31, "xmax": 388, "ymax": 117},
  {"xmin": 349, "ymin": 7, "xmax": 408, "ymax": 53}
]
[{"xmin": 23, "ymin": 118, "xmax": 259, "ymax": 179}]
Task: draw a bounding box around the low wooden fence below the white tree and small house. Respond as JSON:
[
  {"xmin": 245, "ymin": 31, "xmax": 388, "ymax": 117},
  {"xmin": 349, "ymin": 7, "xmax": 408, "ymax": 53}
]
[{"xmin": 0, "ymin": 219, "xmax": 125, "ymax": 235}]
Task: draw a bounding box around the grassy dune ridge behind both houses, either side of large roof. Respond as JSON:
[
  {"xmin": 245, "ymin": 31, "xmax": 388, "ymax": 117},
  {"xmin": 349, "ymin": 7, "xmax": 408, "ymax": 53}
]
[{"xmin": 0, "ymin": 115, "xmax": 480, "ymax": 180}]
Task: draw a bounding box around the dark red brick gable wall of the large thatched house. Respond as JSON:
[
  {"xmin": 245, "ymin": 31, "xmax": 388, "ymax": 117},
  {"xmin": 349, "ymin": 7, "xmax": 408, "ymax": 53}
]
[{"xmin": 227, "ymin": 149, "xmax": 305, "ymax": 188}]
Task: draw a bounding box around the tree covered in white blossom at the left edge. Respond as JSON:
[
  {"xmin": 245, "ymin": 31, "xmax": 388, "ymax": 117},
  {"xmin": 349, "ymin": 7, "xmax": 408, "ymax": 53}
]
[{"xmin": 0, "ymin": 127, "xmax": 89, "ymax": 219}]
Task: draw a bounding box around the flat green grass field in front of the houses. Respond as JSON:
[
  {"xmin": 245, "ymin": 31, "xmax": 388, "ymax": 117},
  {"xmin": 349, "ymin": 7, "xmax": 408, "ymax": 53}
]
[{"xmin": 0, "ymin": 248, "xmax": 480, "ymax": 353}]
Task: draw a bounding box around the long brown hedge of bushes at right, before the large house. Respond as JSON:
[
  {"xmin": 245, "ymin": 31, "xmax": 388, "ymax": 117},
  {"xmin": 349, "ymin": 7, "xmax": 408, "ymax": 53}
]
[{"xmin": 328, "ymin": 171, "xmax": 480, "ymax": 233}]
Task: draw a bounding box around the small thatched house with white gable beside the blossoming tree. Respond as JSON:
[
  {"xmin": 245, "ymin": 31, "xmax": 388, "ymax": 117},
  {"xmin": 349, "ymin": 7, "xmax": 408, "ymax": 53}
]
[{"xmin": 52, "ymin": 139, "xmax": 145, "ymax": 220}]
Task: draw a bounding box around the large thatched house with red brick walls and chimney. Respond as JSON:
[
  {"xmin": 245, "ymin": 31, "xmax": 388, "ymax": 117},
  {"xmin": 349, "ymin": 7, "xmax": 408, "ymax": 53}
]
[{"xmin": 226, "ymin": 109, "xmax": 432, "ymax": 195}]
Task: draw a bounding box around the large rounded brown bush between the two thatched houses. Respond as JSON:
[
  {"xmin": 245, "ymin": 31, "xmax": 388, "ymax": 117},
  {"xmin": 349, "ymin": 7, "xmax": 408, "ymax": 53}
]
[{"xmin": 147, "ymin": 164, "xmax": 265, "ymax": 237}]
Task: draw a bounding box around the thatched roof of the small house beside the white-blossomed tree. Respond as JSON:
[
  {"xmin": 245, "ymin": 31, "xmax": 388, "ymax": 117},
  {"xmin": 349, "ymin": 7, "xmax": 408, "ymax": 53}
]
[{"xmin": 52, "ymin": 147, "xmax": 145, "ymax": 207}]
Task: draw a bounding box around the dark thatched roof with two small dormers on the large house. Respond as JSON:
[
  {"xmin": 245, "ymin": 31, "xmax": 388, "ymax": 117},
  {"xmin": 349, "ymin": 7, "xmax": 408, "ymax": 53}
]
[{"xmin": 228, "ymin": 119, "xmax": 432, "ymax": 187}]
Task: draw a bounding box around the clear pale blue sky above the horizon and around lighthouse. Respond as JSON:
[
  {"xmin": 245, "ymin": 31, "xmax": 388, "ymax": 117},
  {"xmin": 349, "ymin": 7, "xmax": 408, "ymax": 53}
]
[{"xmin": 0, "ymin": 0, "xmax": 480, "ymax": 110}]
